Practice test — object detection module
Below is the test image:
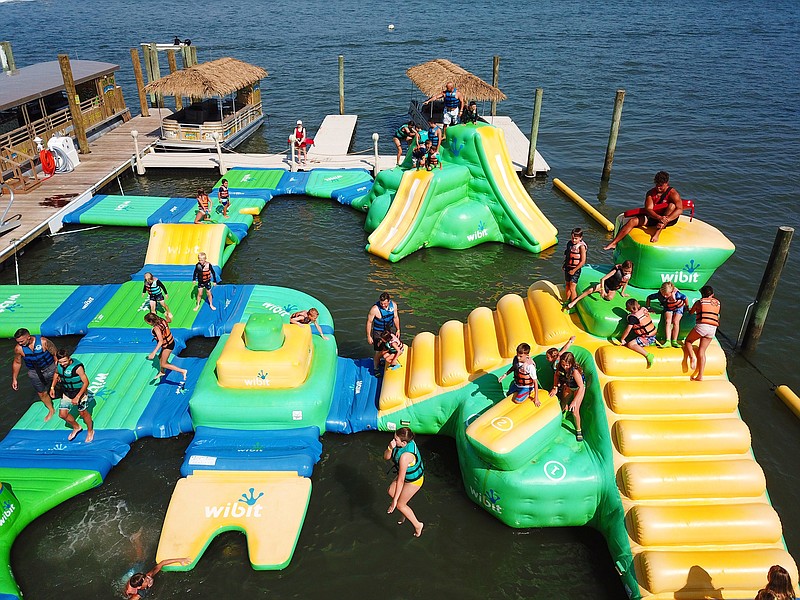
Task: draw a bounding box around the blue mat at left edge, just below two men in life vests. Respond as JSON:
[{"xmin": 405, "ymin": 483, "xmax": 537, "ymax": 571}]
[{"xmin": 0, "ymin": 432, "xmax": 135, "ymax": 479}]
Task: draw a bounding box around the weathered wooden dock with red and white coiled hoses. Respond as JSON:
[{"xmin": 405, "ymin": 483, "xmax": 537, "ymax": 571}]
[{"xmin": 0, "ymin": 109, "xmax": 163, "ymax": 262}]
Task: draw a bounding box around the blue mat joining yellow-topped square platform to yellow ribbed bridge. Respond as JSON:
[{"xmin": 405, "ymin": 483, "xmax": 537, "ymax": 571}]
[{"xmin": 325, "ymin": 357, "xmax": 380, "ymax": 433}]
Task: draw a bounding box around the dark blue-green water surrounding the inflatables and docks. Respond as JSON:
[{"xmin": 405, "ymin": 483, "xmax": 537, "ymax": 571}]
[{"xmin": 0, "ymin": 0, "xmax": 800, "ymax": 598}]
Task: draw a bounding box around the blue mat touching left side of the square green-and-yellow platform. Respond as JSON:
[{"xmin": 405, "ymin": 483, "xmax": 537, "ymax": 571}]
[{"xmin": 136, "ymin": 356, "xmax": 206, "ymax": 439}]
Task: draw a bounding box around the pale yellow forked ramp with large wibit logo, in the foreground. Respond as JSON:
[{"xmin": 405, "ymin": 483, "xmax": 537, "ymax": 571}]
[{"xmin": 156, "ymin": 471, "xmax": 311, "ymax": 571}]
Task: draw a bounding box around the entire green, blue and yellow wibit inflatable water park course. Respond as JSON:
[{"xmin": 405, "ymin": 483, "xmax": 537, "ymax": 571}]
[{"xmin": 0, "ymin": 126, "xmax": 797, "ymax": 599}]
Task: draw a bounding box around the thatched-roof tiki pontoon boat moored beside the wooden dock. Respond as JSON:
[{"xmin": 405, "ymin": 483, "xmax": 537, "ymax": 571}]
[{"xmin": 145, "ymin": 58, "xmax": 267, "ymax": 148}]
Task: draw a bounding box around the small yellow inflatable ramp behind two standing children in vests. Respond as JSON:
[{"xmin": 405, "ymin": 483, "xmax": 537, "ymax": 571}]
[{"xmin": 144, "ymin": 223, "xmax": 239, "ymax": 267}]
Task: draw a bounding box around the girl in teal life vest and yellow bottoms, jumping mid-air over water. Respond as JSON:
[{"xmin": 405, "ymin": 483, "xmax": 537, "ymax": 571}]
[{"xmin": 383, "ymin": 427, "xmax": 425, "ymax": 537}]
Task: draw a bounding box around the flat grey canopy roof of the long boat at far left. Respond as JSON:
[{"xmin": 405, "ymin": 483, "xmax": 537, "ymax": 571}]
[{"xmin": 0, "ymin": 60, "xmax": 119, "ymax": 111}]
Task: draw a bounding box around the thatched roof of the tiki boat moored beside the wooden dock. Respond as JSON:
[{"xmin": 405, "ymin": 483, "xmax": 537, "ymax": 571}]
[{"xmin": 144, "ymin": 58, "xmax": 267, "ymax": 98}]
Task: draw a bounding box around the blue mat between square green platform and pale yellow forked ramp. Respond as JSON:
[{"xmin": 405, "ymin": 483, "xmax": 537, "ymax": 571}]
[{"xmin": 181, "ymin": 426, "xmax": 322, "ymax": 477}]
